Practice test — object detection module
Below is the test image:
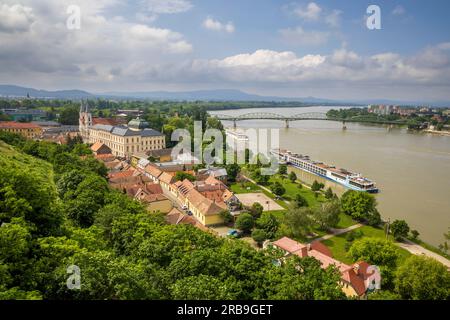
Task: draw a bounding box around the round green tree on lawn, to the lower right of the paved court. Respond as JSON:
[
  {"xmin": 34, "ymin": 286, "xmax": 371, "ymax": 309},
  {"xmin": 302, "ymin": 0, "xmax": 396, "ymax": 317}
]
[{"xmin": 283, "ymin": 208, "xmax": 313, "ymax": 238}]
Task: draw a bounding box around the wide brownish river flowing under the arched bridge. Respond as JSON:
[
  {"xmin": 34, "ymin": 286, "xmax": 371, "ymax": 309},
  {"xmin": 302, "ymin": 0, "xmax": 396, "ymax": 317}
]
[{"xmin": 210, "ymin": 107, "xmax": 450, "ymax": 245}]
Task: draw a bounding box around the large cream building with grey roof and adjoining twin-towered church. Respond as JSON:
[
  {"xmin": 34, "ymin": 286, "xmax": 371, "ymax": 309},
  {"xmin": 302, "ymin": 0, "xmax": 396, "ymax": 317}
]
[{"xmin": 79, "ymin": 104, "xmax": 166, "ymax": 158}]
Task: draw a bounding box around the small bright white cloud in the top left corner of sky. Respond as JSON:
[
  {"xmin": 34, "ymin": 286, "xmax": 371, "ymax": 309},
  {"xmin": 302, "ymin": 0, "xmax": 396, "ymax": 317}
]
[{"xmin": 0, "ymin": 4, "xmax": 34, "ymax": 32}]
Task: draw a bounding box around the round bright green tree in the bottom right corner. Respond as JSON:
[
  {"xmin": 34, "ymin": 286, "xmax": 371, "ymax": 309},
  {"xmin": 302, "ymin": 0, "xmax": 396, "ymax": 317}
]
[{"xmin": 395, "ymin": 255, "xmax": 450, "ymax": 300}]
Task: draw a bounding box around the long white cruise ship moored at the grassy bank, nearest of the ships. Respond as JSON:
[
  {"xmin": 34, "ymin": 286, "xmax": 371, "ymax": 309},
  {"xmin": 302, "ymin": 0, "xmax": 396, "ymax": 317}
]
[{"xmin": 271, "ymin": 149, "xmax": 379, "ymax": 193}]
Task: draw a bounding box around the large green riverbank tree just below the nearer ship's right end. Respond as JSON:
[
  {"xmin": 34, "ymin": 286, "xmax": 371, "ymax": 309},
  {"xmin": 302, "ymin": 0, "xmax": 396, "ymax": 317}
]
[{"xmin": 341, "ymin": 190, "xmax": 381, "ymax": 225}]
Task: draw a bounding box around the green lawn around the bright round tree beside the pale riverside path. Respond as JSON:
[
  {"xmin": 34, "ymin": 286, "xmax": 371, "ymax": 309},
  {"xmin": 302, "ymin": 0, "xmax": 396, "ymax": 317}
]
[{"xmin": 322, "ymin": 222, "xmax": 411, "ymax": 264}]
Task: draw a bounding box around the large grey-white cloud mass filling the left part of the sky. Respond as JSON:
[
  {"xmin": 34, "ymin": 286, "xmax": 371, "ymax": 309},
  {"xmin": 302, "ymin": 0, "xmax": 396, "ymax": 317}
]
[{"xmin": 0, "ymin": 0, "xmax": 192, "ymax": 86}]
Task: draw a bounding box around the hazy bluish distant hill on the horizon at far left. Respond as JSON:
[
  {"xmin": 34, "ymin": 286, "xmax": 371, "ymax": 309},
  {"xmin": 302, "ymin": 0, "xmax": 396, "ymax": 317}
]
[{"xmin": 0, "ymin": 85, "xmax": 93, "ymax": 99}]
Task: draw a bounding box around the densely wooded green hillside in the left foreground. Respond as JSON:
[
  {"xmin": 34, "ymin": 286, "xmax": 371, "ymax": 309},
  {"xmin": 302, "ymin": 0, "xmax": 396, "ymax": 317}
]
[{"xmin": 0, "ymin": 133, "xmax": 344, "ymax": 299}]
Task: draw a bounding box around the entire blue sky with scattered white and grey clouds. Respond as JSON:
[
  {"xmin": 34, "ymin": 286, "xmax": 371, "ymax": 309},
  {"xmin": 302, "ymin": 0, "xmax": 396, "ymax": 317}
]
[{"xmin": 0, "ymin": 0, "xmax": 450, "ymax": 100}]
